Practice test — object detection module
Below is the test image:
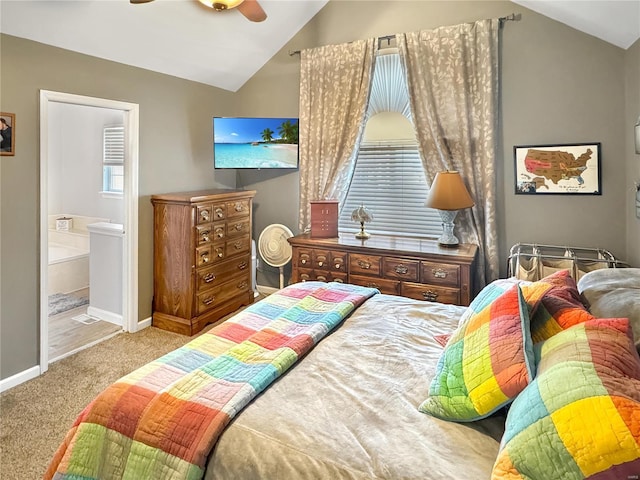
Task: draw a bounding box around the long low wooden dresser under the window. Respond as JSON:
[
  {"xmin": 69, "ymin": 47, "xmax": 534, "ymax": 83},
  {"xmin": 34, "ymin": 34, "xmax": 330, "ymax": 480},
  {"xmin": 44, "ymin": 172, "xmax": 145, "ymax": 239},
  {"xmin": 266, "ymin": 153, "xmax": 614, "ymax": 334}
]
[{"xmin": 289, "ymin": 234, "xmax": 478, "ymax": 306}]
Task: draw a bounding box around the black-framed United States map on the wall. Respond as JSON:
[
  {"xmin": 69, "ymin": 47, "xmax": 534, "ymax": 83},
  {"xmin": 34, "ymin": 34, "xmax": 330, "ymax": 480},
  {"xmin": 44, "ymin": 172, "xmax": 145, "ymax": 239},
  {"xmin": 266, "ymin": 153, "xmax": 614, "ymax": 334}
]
[{"xmin": 513, "ymin": 142, "xmax": 602, "ymax": 195}]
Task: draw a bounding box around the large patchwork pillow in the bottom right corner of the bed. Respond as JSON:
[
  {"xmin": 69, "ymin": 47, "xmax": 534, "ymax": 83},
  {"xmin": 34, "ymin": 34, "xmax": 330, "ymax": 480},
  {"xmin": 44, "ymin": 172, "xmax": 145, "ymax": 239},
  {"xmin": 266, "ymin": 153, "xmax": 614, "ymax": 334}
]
[{"xmin": 491, "ymin": 318, "xmax": 640, "ymax": 480}]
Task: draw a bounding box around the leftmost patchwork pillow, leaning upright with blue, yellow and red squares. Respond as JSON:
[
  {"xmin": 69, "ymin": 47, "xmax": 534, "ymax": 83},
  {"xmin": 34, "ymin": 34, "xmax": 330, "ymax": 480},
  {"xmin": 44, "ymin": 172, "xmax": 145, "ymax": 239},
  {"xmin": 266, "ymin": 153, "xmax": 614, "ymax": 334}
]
[{"xmin": 419, "ymin": 281, "xmax": 550, "ymax": 422}]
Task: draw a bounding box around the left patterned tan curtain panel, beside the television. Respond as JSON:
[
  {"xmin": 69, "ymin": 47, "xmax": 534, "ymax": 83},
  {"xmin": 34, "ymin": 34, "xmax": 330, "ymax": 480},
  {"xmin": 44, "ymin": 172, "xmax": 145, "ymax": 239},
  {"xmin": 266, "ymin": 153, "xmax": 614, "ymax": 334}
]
[{"xmin": 299, "ymin": 38, "xmax": 375, "ymax": 231}]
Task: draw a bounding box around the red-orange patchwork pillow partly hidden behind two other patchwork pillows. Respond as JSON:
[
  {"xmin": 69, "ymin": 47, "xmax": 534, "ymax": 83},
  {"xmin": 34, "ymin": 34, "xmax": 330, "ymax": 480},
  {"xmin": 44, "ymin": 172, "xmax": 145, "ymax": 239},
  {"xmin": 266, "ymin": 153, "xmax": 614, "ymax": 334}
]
[{"xmin": 531, "ymin": 270, "xmax": 595, "ymax": 343}]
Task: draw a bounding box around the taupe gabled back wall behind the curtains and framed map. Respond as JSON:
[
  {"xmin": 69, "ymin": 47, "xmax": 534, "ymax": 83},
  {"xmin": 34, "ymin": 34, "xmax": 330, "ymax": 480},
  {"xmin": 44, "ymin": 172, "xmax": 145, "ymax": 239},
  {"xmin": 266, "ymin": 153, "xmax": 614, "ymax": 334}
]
[{"xmin": 239, "ymin": 0, "xmax": 629, "ymax": 285}]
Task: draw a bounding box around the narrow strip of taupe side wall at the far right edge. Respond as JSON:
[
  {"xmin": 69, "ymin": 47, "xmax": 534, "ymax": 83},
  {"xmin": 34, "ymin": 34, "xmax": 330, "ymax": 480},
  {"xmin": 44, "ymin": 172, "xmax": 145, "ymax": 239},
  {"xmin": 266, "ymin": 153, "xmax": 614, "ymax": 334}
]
[{"xmin": 622, "ymin": 40, "xmax": 640, "ymax": 265}]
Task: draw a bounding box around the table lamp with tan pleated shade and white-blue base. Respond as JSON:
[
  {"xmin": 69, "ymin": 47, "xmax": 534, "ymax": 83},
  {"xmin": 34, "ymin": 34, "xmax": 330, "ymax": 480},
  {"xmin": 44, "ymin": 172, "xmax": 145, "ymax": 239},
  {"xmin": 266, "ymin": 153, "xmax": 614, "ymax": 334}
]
[{"xmin": 425, "ymin": 170, "xmax": 474, "ymax": 247}]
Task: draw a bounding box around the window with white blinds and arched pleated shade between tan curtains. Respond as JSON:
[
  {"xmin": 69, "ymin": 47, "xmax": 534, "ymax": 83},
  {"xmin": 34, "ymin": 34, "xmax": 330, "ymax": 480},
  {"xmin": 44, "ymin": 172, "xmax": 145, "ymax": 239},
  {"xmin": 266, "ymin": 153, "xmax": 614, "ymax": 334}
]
[{"xmin": 338, "ymin": 53, "xmax": 442, "ymax": 238}]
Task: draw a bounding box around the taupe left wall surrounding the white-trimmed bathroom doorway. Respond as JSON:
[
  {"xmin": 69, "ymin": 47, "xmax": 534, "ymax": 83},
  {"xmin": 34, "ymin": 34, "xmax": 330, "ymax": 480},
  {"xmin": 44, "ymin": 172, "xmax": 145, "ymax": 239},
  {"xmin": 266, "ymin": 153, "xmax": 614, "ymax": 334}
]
[{"xmin": 0, "ymin": 35, "xmax": 235, "ymax": 379}]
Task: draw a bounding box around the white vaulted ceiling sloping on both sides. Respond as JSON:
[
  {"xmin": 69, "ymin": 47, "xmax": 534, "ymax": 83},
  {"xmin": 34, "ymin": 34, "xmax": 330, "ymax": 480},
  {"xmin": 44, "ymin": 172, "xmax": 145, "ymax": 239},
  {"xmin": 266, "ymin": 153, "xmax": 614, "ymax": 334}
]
[{"xmin": 0, "ymin": 0, "xmax": 640, "ymax": 92}]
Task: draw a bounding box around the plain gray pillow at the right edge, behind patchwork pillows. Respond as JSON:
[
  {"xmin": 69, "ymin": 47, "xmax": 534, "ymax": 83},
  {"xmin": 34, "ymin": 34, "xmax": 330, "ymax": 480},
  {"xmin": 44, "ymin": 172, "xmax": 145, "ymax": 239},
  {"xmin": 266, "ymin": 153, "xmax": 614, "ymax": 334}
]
[{"xmin": 578, "ymin": 268, "xmax": 640, "ymax": 351}]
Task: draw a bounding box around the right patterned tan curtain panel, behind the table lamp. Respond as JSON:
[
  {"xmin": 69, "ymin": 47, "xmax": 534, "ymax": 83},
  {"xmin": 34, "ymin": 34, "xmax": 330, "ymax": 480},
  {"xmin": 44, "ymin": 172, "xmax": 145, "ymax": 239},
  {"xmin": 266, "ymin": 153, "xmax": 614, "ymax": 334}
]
[{"xmin": 396, "ymin": 19, "xmax": 500, "ymax": 288}]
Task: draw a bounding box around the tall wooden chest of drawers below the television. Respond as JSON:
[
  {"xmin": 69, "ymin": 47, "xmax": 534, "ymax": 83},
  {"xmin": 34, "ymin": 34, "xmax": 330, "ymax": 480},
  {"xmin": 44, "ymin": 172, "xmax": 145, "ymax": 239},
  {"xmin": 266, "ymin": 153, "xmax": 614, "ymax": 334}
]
[{"xmin": 151, "ymin": 189, "xmax": 256, "ymax": 335}]
